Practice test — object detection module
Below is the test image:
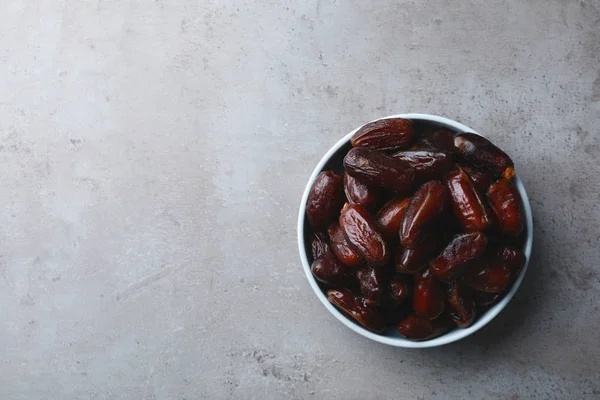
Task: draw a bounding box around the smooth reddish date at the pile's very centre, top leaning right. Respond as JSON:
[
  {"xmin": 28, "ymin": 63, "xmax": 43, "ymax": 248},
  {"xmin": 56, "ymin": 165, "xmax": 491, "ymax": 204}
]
[{"xmin": 400, "ymin": 181, "xmax": 448, "ymax": 249}]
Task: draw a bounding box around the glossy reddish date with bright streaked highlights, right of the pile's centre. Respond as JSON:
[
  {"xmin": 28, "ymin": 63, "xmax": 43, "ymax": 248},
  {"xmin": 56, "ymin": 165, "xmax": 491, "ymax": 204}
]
[{"xmin": 444, "ymin": 167, "xmax": 493, "ymax": 232}]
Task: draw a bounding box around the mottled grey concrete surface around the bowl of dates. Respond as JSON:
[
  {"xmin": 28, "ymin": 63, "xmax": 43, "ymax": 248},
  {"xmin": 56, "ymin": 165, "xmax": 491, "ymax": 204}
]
[{"xmin": 0, "ymin": 0, "xmax": 600, "ymax": 400}]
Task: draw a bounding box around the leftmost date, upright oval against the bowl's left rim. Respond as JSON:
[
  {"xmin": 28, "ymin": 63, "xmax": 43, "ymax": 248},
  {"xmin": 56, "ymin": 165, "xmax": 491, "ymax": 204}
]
[{"xmin": 306, "ymin": 171, "xmax": 344, "ymax": 231}]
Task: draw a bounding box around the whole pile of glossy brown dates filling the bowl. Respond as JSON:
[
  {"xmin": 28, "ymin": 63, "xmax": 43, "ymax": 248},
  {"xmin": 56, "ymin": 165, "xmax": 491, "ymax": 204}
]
[{"xmin": 306, "ymin": 118, "xmax": 525, "ymax": 340}]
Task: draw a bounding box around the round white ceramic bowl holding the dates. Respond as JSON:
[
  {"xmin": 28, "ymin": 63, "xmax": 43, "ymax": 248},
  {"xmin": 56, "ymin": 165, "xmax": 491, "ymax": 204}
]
[{"xmin": 298, "ymin": 114, "xmax": 533, "ymax": 348}]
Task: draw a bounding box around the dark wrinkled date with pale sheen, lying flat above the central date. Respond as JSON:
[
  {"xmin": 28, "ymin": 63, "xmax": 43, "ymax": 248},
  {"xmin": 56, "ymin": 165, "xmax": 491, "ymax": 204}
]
[{"xmin": 392, "ymin": 150, "xmax": 453, "ymax": 182}]
